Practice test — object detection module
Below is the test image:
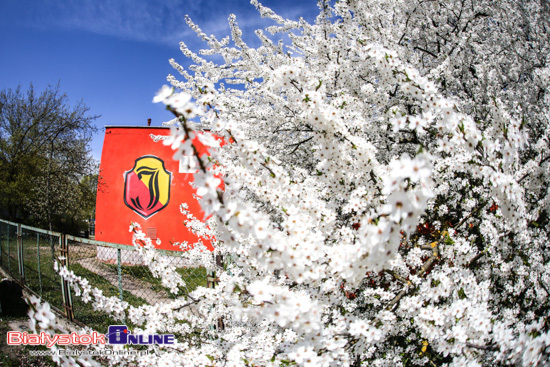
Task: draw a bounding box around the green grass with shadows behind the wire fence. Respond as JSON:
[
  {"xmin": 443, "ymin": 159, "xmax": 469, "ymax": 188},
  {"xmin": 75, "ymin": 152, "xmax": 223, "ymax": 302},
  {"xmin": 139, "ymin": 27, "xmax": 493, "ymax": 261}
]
[{"xmin": 0, "ymin": 233, "xmax": 207, "ymax": 332}]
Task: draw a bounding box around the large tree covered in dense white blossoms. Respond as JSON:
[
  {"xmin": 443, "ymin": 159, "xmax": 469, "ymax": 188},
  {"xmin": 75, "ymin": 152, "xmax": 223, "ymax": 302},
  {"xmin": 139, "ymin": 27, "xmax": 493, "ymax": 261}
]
[{"xmin": 36, "ymin": 0, "xmax": 550, "ymax": 366}]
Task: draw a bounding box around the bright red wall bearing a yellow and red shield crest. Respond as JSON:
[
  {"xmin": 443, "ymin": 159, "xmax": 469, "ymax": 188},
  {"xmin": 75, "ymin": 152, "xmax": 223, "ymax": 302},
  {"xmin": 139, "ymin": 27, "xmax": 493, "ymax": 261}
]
[{"xmin": 95, "ymin": 126, "xmax": 212, "ymax": 250}]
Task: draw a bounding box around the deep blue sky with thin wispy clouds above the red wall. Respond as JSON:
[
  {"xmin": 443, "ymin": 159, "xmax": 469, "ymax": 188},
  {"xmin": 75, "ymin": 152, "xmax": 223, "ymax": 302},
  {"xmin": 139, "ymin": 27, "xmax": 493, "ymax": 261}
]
[{"xmin": 0, "ymin": 0, "xmax": 318, "ymax": 159}]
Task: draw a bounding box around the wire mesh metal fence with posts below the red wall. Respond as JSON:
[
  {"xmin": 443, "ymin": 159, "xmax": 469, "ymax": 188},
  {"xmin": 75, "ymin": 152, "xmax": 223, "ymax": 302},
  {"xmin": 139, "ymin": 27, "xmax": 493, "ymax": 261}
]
[{"xmin": 0, "ymin": 219, "xmax": 211, "ymax": 329}]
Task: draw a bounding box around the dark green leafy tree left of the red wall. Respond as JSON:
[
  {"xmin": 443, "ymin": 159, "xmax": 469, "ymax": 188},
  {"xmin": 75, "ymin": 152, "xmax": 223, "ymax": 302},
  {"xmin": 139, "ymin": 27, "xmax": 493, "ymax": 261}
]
[{"xmin": 0, "ymin": 84, "xmax": 98, "ymax": 231}]
